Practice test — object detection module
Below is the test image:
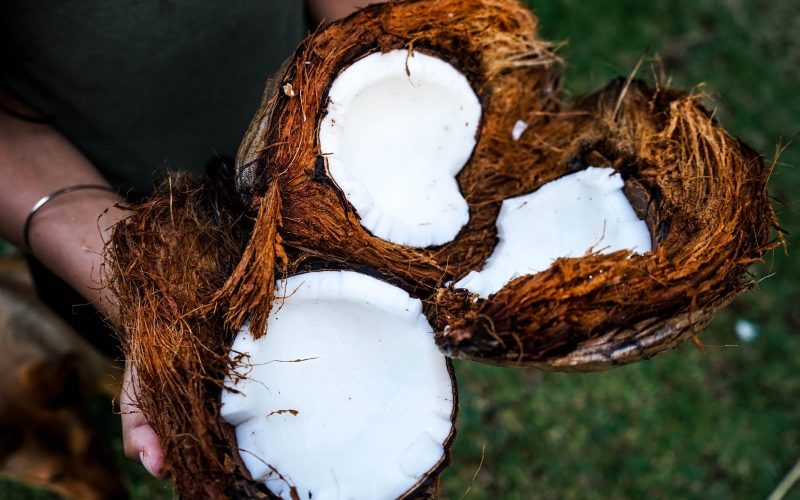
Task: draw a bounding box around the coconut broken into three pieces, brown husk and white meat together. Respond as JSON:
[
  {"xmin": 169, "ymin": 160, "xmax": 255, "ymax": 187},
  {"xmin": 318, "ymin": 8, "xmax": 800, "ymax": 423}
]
[{"xmin": 109, "ymin": 0, "xmax": 775, "ymax": 498}]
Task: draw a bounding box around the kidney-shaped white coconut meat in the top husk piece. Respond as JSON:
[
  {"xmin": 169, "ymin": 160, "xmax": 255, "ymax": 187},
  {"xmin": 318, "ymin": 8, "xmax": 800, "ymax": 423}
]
[{"xmin": 319, "ymin": 50, "xmax": 481, "ymax": 247}]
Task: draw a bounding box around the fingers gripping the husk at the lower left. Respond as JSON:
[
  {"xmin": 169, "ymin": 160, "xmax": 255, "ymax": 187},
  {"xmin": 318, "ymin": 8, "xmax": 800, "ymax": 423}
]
[{"xmin": 120, "ymin": 363, "xmax": 167, "ymax": 479}]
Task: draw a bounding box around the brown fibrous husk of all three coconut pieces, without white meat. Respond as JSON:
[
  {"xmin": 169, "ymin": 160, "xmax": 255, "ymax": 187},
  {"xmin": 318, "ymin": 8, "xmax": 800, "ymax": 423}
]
[{"xmin": 107, "ymin": 0, "xmax": 776, "ymax": 498}]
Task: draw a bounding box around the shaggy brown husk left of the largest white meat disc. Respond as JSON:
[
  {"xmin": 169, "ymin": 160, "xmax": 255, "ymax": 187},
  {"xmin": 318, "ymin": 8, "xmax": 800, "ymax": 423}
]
[{"xmin": 107, "ymin": 174, "xmax": 270, "ymax": 498}]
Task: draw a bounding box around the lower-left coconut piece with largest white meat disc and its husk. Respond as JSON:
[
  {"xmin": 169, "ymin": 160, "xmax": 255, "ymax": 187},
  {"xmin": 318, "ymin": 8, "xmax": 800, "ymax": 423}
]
[{"xmin": 107, "ymin": 173, "xmax": 457, "ymax": 498}]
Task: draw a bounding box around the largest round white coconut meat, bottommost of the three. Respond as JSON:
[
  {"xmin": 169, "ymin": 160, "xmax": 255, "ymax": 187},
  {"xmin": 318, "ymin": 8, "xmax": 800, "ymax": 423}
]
[{"xmin": 221, "ymin": 271, "xmax": 455, "ymax": 500}]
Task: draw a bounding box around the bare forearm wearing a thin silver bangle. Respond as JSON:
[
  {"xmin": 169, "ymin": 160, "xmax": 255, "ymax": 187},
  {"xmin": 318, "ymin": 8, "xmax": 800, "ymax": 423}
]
[{"xmin": 0, "ymin": 95, "xmax": 123, "ymax": 315}]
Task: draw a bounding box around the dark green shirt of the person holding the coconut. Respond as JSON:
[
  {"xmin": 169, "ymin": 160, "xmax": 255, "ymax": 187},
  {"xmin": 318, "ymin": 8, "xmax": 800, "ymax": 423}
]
[{"xmin": 0, "ymin": 0, "xmax": 305, "ymax": 193}]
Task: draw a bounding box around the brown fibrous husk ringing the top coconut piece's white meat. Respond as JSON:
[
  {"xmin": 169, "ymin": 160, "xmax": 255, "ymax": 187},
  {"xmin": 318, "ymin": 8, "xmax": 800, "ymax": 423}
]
[{"xmin": 230, "ymin": 0, "xmax": 558, "ymax": 304}]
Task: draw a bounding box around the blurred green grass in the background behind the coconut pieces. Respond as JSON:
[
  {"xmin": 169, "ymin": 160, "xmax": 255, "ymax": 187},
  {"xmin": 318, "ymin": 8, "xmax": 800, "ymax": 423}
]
[{"xmin": 0, "ymin": 0, "xmax": 800, "ymax": 499}]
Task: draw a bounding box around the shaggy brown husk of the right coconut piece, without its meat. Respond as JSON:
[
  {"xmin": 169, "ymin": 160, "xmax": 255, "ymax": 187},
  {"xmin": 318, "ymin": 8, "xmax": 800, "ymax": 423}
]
[{"xmin": 428, "ymin": 79, "xmax": 778, "ymax": 371}]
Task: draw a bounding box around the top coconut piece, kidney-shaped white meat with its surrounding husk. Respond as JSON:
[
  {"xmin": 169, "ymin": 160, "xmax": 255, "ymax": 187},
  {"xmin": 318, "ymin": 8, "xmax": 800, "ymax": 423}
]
[{"xmin": 237, "ymin": 0, "xmax": 558, "ymax": 322}]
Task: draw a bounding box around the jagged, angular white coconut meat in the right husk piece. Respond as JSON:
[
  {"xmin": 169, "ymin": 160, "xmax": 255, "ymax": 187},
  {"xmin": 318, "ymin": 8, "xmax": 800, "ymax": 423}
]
[{"xmin": 455, "ymin": 167, "xmax": 651, "ymax": 298}]
